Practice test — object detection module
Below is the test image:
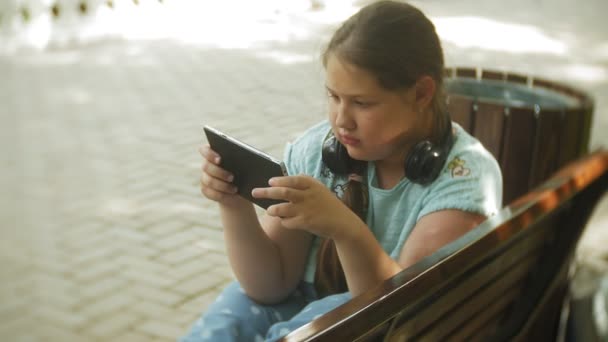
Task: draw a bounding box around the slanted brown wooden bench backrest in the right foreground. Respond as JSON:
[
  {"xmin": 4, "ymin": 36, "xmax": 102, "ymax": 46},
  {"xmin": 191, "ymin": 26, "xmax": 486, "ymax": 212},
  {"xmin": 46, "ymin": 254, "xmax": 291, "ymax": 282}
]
[{"xmin": 284, "ymin": 151, "xmax": 608, "ymax": 341}]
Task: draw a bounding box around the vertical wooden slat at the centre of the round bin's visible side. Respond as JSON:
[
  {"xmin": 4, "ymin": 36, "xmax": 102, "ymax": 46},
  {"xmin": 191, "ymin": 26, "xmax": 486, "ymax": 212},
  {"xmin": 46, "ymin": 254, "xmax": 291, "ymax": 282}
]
[{"xmin": 498, "ymin": 108, "xmax": 536, "ymax": 203}]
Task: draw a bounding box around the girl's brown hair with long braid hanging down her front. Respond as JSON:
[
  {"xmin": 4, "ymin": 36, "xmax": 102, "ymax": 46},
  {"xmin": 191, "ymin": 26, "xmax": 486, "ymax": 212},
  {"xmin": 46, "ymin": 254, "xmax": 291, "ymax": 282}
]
[{"xmin": 315, "ymin": 1, "xmax": 449, "ymax": 295}]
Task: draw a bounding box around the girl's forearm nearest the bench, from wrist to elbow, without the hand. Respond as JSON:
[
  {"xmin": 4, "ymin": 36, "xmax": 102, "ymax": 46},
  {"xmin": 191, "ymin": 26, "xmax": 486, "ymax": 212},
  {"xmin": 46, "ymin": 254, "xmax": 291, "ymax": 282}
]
[{"xmin": 334, "ymin": 220, "xmax": 402, "ymax": 297}]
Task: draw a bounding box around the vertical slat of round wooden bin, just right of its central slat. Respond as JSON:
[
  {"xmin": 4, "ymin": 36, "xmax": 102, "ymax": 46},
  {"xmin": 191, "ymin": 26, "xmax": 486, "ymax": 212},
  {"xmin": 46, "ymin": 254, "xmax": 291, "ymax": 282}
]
[{"xmin": 529, "ymin": 110, "xmax": 562, "ymax": 188}]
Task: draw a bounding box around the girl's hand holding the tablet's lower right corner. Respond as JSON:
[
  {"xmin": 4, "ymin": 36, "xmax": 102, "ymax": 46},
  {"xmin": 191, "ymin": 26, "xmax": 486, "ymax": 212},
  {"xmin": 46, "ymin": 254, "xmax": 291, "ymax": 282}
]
[{"xmin": 252, "ymin": 176, "xmax": 360, "ymax": 239}]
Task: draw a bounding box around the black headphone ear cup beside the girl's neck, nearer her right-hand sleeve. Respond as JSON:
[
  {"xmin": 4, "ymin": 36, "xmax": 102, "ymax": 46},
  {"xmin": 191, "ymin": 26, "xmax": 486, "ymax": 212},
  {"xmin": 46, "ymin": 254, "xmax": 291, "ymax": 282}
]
[{"xmin": 405, "ymin": 140, "xmax": 445, "ymax": 185}]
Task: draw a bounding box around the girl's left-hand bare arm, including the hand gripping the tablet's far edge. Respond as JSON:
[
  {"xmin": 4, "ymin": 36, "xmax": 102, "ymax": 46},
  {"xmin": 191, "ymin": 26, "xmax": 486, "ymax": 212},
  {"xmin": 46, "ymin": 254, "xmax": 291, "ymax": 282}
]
[{"xmin": 200, "ymin": 145, "xmax": 312, "ymax": 303}]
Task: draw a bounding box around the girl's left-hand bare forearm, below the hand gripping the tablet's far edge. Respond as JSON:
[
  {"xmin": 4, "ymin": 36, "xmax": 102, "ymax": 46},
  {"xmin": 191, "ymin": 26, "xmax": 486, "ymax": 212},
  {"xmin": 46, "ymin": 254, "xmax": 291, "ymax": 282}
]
[{"xmin": 220, "ymin": 202, "xmax": 284, "ymax": 302}]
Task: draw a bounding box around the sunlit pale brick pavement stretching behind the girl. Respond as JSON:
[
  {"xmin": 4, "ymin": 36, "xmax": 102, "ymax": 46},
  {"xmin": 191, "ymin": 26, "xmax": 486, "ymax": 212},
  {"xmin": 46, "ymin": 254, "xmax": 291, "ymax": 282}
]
[{"xmin": 0, "ymin": 1, "xmax": 608, "ymax": 341}]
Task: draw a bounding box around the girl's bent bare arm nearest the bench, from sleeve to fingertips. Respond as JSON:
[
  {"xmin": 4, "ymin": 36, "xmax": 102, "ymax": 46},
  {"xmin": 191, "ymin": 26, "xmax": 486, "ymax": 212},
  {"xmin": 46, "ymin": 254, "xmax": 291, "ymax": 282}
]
[{"xmin": 253, "ymin": 176, "xmax": 485, "ymax": 296}]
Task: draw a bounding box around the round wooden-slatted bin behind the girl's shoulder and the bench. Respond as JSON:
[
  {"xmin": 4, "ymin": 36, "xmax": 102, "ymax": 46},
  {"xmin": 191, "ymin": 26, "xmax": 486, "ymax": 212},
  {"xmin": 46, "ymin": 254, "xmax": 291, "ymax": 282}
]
[{"xmin": 446, "ymin": 68, "xmax": 593, "ymax": 204}]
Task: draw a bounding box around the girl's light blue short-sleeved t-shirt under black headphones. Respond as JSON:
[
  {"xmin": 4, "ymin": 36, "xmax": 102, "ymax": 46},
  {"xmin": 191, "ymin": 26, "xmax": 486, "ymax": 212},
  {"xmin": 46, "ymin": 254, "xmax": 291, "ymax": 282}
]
[{"xmin": 283, "ymin": 120, "xmax": 502, "ymax": 283}]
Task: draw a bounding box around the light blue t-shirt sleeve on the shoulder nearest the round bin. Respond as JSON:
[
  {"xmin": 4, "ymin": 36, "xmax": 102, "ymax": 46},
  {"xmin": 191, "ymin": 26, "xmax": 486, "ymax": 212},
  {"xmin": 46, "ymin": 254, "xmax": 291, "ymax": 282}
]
[{"xmin": 418, "ymin": 148, "xmax": 502, "ymax": 220}]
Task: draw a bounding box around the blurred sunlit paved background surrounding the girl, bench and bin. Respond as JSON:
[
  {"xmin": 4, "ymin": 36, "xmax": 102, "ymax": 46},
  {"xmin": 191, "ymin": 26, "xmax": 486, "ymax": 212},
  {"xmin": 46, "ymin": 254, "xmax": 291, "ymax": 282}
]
[{"xmin": 0, "ymin": 0, "xmax": 608, "ymax": 341}]
